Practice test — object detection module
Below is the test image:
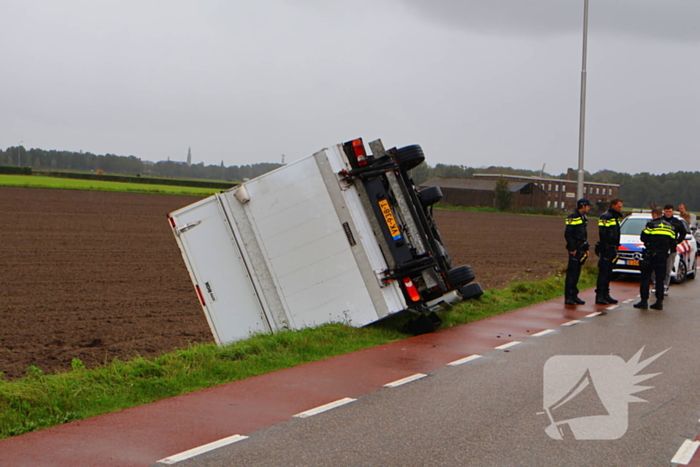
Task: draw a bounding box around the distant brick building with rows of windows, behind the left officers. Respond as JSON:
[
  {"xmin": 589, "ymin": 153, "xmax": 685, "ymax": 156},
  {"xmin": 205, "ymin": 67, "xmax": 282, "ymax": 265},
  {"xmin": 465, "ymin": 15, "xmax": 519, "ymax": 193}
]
[{"xmin": 474, "ymin": 171, "xmax": 620, "ymax": 210}]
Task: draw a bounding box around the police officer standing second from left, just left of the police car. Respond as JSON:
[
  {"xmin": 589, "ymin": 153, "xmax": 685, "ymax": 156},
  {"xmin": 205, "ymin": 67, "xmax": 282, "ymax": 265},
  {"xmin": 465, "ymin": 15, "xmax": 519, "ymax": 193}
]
[{"xmin": 595, "ymin": 198, "xmax": 622, "ymax": 305}]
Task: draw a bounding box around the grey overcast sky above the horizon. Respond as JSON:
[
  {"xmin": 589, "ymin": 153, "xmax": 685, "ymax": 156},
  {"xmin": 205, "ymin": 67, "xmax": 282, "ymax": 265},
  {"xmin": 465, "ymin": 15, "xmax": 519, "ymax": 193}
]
[{"xmin": 0, "ymin": 0, "xmax": 700, "ymax": 174}]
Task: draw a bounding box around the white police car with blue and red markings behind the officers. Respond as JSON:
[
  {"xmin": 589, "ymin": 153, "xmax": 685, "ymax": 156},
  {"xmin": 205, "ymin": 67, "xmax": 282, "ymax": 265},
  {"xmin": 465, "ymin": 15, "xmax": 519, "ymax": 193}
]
[{"xmin": 613, "ymin": 211, "xmax": 698, "ymax": 284}]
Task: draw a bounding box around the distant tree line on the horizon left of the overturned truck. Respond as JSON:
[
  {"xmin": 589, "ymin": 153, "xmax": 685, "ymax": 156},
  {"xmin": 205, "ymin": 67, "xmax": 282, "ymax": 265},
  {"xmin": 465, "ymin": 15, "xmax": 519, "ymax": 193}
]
[{"xmin": 0, "ymin": 146, "xmax": 281, "ymax": 182}]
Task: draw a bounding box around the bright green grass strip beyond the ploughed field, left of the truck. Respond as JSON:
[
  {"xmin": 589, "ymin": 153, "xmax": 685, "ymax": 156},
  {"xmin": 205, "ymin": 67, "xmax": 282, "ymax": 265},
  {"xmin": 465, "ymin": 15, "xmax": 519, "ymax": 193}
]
[{"xmin": 0, "ymin": 175, "xmax": 221, "ymax": 196}]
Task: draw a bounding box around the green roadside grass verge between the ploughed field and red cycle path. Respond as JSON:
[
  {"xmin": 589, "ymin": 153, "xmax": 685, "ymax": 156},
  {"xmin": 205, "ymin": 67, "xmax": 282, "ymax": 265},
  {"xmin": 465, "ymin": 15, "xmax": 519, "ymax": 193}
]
[{"xmin": 0, "ymin": 267, "xmax": 596, "ymax": 439}]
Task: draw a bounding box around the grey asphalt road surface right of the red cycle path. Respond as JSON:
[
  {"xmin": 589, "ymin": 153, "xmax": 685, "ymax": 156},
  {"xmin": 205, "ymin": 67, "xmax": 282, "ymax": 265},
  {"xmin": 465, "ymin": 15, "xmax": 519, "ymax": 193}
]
[{"xmin": 165, "ymin": 281, "xmax": 700, "ymax": 467}]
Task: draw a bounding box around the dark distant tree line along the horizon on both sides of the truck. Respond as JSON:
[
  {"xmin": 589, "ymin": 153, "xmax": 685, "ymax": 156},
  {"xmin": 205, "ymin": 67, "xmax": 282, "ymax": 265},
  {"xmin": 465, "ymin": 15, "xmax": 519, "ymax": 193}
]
[{"xmin": 0, "ymin": 146, "xmax": 700, "ymax": 211}]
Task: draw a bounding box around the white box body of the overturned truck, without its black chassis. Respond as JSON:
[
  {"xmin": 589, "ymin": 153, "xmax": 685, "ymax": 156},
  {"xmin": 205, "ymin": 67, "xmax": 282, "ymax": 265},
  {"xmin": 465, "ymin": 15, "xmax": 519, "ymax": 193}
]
[{"xmin": 170, "ymin": 145, "xmax": 407, "ymax": 345}]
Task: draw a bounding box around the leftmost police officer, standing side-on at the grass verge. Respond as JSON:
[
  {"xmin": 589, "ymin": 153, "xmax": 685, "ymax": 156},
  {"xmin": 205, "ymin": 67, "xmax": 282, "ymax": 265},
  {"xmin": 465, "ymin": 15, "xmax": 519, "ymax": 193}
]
[{"xmin": 564, "ymin": 198, "xmax": 593, "ymax": 305}]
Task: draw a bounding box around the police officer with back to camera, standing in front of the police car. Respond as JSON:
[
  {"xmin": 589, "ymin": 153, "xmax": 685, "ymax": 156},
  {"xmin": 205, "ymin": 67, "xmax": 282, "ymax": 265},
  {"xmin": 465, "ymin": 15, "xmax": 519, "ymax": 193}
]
[{"xmin": 633, "ymin": 207, "xmax": 676, "ymax": 310}]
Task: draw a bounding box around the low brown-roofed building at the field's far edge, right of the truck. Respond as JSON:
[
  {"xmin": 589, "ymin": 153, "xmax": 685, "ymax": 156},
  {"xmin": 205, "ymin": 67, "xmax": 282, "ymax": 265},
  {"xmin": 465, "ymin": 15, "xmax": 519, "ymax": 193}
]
[{"xmin": 420, "ymin": 177, "xmax": 547, "ymax": 208}]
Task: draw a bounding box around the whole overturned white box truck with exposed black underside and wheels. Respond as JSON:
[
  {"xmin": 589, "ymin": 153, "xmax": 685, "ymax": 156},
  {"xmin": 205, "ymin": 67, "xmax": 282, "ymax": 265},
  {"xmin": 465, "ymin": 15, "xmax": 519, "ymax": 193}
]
[{"xmin": 168, "ymin": 139, "xmax": 483, "ymax": 345}]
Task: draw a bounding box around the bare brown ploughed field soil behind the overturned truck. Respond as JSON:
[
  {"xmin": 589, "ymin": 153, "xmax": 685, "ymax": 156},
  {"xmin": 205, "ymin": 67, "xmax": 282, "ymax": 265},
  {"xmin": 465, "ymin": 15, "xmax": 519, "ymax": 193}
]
[{"xmin": 0, "ymin": 187, "xmax": 593, "ymax": 379}]
